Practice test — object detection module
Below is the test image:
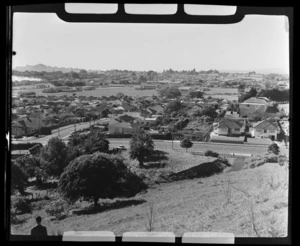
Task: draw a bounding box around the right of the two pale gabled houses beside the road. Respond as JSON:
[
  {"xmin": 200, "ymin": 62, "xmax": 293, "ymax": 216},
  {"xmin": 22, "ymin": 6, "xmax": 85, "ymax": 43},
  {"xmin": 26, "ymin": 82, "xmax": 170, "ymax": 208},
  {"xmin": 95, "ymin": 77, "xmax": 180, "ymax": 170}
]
[{"xmin": 250, "ymin": 120, "xmax": 279, "ymax": 140}]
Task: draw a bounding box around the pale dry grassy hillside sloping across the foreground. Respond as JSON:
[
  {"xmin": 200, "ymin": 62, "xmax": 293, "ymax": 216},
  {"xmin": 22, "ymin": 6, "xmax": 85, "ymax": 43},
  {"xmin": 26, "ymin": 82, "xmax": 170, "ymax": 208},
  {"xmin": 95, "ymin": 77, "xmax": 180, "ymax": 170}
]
[{"xmin": 12, "ymin": 156, "xmax": 288, "ymax": 237}]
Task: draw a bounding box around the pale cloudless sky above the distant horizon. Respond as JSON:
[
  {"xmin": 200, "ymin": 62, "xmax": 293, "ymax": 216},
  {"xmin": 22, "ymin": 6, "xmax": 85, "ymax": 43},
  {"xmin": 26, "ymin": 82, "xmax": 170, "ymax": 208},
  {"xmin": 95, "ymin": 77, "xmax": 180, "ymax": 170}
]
[{"xmin": 13, "ymin": 13, "xmax": 289, "ymax": 74}]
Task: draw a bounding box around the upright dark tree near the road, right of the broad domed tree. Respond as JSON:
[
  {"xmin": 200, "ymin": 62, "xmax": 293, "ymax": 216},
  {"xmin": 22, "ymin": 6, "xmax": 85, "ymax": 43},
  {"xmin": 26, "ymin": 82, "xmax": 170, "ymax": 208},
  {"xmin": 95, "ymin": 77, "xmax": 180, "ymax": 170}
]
[{"xmin": 129, "ymin": 130, "xmax": 154, "ymax": 167}]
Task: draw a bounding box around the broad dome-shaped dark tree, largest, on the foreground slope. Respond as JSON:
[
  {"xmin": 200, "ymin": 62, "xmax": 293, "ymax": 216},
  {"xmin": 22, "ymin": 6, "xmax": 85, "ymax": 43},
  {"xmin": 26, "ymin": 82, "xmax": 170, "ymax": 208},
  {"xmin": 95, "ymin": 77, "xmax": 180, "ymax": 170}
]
[{"xmin": 58, "ymin": 153, "xmax": 147, "ymax": 206}]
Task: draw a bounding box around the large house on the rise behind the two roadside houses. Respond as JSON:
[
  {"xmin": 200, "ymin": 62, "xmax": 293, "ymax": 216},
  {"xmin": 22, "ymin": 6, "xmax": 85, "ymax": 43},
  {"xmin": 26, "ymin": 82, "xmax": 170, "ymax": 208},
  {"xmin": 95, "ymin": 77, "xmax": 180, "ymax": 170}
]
[{"xmin": 239, "ymin": 97, "xmax": 270, "ymax": 117}]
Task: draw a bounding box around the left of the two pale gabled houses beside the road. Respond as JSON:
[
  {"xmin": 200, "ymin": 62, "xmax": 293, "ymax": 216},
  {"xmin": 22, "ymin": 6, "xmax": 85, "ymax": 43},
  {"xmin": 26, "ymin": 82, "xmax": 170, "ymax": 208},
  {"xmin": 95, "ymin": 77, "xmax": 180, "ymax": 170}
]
[{"xmin": 214, "ymin": 118, "xmax": 247, "ymax": 136}]
